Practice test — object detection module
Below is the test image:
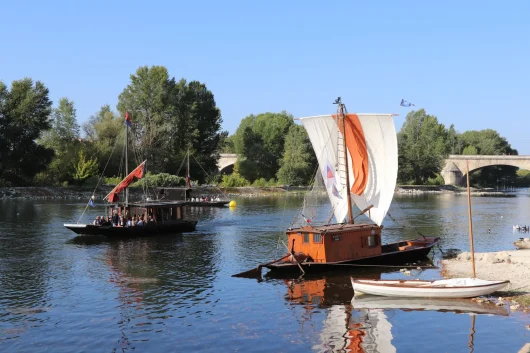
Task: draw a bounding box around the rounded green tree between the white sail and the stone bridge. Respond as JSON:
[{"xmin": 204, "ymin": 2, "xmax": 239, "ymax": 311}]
[{"xmin": 397, "ymin": 109, "xmax": 450, "ymax": 184}]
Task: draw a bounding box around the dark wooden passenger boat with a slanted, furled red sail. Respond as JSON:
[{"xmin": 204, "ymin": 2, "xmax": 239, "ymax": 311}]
[{"xmin": 64, "ymin": 112, "xmax": 197, "ymax": 237}]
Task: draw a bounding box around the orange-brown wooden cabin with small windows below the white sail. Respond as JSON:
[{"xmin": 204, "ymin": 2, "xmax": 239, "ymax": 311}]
[{"xmin": 287, "ymin": 224, "xmax": 382, "ymax": 263}]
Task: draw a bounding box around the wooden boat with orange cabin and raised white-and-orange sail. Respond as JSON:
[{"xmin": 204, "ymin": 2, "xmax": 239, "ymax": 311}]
[{"xmin": 234, "ymin": 97, "xmax": 439, "ymax": 277}]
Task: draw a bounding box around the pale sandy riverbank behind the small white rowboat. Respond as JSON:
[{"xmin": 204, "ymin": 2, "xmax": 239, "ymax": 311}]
[{"xmin": 441, "ymin": 250, "xmax": 530, "ymax": 309}]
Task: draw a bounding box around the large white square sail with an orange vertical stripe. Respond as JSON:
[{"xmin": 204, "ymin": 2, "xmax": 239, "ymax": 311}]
[{"xmin": 300, "ymin": 114, "xmax": 398, "ymax": 225}]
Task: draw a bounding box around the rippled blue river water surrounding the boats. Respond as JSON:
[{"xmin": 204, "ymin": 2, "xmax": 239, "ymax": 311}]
[{"xmin": 0, "ymin": 192, "xmax": 530, "ymax": 353}]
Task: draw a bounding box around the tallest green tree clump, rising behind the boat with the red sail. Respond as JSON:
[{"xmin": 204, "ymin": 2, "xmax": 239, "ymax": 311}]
[{"xmin": 118, "ymin": 66, "xmax": 222, "ymax": 181}]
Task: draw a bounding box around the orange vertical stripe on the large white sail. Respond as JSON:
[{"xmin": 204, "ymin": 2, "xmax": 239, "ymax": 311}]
[{"xmin": 333, "ymin": 114, "xmax": 368, "ymax": 195}]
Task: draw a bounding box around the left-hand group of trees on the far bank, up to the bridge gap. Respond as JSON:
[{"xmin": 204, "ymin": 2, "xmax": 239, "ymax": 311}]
[{"xmin": 0, "ymin": 66, "xmax": 228, "ymax": 186}]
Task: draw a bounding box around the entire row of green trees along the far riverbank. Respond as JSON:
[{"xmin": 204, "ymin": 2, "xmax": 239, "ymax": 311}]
[{"xmin": 0, "ymin": 71, "xmax": 520, "ymax": 187}]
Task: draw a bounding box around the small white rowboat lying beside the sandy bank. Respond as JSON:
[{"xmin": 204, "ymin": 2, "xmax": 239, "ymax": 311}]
[{"xmin": 351, "ymin": 278, "xmax": 510, "ymax": 298}]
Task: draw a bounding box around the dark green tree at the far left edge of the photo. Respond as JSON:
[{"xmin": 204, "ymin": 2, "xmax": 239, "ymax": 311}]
[{"xmin": 0, "ymin": 78, "xmax": 53, "ymax": 186}]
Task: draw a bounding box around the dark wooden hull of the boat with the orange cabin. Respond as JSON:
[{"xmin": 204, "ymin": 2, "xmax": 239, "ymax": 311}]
[{"xmin": 264, "ymin": 238, "xmax": 440, "ymax": 274}]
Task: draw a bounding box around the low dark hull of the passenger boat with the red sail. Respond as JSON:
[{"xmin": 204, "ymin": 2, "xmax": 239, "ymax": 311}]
[{"xmin": 64, "ymin": 220, "xmax": 197, "ymax": 238}]
